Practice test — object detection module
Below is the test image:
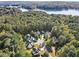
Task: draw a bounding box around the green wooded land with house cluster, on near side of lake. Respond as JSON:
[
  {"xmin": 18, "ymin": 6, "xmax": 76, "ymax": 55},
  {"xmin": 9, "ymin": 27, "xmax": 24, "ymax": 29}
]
[{"xmin": 0, "ymin": 9, "xmax": 79, "ymax": 57}]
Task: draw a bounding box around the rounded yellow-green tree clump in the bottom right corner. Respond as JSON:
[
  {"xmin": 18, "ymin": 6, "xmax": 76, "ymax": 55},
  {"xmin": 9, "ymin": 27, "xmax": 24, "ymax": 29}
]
[{"xmin": 58, "ymin": 39, "xmax": 79, "ymax": 57}]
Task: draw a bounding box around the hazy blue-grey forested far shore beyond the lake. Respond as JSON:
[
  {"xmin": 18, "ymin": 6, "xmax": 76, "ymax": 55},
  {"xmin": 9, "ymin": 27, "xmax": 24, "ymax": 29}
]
[{"xmin": 0, "ymin": 1, "xmax": 79, "ymax": 11}]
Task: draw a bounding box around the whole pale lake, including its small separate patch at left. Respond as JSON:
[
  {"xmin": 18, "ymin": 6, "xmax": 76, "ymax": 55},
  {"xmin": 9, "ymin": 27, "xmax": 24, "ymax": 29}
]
[{"xmin": 20, "ymin": 8, "xmax": 79, "ymax": 16}]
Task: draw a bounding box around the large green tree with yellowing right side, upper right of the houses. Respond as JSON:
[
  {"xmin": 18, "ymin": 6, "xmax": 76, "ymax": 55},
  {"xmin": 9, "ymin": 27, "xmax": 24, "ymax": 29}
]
[{"xmin": 51, "ymin": 20, "xmax": 75, "ymax": 47}]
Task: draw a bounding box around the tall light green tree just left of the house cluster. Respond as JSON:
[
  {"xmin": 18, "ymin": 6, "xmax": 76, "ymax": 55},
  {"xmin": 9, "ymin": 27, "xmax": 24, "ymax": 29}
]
[{"xmin": 12, "ymin": 33, "xmax": 26, "ymax": 57}]
